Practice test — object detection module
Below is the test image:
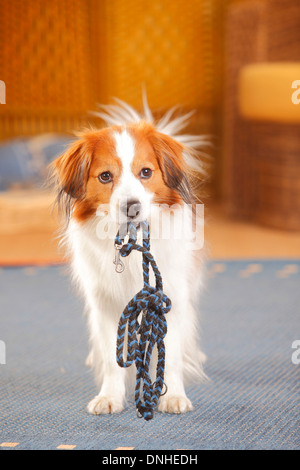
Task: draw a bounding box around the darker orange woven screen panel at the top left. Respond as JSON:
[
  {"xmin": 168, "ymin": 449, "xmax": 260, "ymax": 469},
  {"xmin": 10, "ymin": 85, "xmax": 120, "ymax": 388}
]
[{"xmin": 0, "ymin": 0, "xmax": 101, "ymax": 140}]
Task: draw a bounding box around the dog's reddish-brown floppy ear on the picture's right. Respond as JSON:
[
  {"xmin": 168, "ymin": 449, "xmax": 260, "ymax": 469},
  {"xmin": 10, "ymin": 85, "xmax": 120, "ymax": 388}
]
[{"xmin": 150, "ymin": 131, "xmax": 193, "ymax": 204}]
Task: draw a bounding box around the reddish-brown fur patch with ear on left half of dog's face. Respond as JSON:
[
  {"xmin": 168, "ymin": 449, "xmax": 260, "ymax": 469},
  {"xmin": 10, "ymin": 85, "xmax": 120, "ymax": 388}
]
[{"xmin": 51, "ymin": 129, "xmax": 121, "ymax": 221}]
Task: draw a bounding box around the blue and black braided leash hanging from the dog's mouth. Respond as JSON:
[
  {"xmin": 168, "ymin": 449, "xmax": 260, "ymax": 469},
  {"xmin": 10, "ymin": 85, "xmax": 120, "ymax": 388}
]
[{"xmin": 114, "ymin": 222, "xmax": 171, "ymax": 421}]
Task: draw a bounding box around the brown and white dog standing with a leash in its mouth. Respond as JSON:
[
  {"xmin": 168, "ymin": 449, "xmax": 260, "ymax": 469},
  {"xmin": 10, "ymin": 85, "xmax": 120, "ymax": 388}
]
[{"xmin": 51, "ymin": 100, "xmax": 209, "ymax": 414}]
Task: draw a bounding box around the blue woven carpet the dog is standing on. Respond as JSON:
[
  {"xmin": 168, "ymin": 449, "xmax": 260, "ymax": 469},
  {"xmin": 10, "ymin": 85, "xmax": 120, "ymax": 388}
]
[{"xmin": 0, "ymin": 260, "xmax": 300, "ymax": 450}]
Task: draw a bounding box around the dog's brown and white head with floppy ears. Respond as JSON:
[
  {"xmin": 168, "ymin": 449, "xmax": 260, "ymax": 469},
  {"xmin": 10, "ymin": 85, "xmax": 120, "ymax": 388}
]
[{"xmin": 52, "ymin": 104, "xmax": 206, "ymax": 223}]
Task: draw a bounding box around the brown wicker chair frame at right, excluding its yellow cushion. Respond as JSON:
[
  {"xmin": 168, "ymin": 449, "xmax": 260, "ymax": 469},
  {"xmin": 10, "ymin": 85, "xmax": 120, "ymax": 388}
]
[{"xmin": 222, "ymin": 0, "xmax": 300, "ymax": 230}]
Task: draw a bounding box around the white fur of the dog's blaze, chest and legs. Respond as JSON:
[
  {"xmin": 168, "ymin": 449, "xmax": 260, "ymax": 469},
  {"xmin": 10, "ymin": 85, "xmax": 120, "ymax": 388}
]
[{"xmin": 65, "ymin": 104, "xmax": 205, "ymax": 414}]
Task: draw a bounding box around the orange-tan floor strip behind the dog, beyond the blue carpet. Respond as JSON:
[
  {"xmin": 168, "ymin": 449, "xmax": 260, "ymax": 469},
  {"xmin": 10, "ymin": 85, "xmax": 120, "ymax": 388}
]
[{"xmin": 0, "ymin": 191, "xmax": 300, "ymax": 266}]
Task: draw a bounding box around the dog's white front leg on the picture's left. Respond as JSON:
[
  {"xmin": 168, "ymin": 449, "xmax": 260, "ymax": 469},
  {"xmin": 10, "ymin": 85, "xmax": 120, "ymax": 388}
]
[{"xmin": 87, "ymin": 312, "xmax": 126, "ymax": 415}]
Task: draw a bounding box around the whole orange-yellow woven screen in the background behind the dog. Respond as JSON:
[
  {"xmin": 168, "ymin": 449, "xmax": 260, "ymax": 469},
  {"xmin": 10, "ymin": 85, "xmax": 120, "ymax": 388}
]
[{"xmin": 0, "ymin": 0, "xmax": 223, "ymax": 140}]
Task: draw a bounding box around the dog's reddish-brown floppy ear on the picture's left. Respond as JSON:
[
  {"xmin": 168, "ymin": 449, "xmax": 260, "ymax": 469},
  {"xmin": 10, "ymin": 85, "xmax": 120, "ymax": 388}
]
[{"xmin": 50, "ymin": 139, "xmax": 92, "ymax": 215}]
